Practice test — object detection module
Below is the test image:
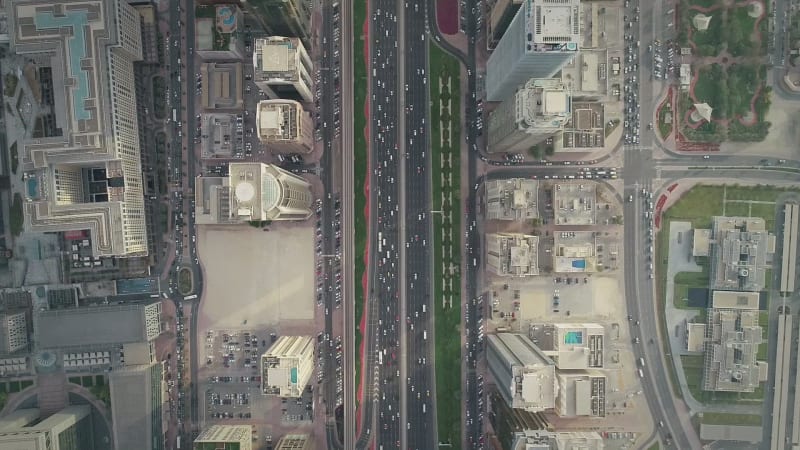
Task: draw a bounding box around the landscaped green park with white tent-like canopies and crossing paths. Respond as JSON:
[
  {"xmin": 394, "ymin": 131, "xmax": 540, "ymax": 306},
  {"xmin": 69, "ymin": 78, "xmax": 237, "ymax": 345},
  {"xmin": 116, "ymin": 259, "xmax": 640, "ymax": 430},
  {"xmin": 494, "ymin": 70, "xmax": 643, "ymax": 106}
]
[{"xmin": 674, "ymin": 0, "xmax": 770, "ymax": 143}]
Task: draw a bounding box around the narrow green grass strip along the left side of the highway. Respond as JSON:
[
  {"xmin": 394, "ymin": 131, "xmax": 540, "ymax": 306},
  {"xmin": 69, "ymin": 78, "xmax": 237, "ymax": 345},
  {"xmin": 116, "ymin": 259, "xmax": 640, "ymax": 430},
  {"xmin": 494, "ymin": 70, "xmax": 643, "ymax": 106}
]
[{"xmin": 353, "ymin": 1, "xmax": 368, "ymax": 406}]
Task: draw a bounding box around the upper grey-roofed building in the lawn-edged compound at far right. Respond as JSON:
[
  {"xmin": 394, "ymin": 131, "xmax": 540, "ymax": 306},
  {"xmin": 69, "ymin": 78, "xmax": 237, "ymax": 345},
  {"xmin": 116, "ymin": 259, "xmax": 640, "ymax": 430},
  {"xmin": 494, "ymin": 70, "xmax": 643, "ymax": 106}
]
[{"xmin": 710, "ymin": 216, "xmax": 775, "ymax": 291}]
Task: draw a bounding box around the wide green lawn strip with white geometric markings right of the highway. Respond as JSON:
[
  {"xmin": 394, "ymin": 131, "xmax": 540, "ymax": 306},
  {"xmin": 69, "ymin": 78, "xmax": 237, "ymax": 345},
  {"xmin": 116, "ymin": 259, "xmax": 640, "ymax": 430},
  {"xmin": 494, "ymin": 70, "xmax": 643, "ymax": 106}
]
[{"xmin": 429, "ymin": 41, "xmax": 461, "ymax": 449}]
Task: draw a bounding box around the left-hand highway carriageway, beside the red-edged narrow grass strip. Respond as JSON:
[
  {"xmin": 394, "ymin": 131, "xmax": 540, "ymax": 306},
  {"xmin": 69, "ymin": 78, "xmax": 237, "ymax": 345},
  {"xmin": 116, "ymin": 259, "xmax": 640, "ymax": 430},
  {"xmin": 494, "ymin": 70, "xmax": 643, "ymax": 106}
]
[{"xmin": 366, "ymin": 0, "xmax": 404, "ymax": 448}]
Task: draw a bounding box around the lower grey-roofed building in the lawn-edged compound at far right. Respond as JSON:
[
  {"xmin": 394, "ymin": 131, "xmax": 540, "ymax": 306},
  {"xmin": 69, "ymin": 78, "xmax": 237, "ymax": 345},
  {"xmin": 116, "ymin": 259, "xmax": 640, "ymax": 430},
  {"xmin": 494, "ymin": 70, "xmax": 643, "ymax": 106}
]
[{"xmin": 703, "ymin": 291, "xmax": 763, "ymax": 392}]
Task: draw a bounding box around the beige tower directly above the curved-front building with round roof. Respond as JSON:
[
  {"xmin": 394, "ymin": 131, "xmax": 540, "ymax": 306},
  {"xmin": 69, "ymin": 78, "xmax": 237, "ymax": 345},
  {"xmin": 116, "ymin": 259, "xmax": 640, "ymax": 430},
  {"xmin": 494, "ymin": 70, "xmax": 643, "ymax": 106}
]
[{"xmin": 256, "ymin": 100, "xmax": 314, "ymax": 153}]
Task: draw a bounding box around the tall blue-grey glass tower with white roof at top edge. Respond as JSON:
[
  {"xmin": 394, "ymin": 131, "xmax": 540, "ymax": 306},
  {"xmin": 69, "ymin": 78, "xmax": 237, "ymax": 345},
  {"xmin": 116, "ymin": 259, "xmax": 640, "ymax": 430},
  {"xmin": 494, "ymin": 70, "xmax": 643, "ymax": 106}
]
[{"xmin": 486, "ymin": 0, "xmax": 580, "ymax": 102}]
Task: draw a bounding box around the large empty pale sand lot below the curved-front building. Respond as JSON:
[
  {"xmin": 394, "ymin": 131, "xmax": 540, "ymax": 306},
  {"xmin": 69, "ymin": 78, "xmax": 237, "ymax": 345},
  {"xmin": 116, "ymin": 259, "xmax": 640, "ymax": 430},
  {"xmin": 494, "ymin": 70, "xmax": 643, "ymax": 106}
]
[{"xmin": 197, "ymin": 224, "xmax": 315, "ymax": 330}]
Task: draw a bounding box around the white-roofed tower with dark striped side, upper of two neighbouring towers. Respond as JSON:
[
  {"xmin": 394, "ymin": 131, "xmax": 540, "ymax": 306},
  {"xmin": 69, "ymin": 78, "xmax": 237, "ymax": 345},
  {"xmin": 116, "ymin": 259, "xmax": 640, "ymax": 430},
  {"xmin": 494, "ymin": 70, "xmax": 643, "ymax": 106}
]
[{"xmin": 253, "ymin": 36, "xmax": 314, "ymax": 103}]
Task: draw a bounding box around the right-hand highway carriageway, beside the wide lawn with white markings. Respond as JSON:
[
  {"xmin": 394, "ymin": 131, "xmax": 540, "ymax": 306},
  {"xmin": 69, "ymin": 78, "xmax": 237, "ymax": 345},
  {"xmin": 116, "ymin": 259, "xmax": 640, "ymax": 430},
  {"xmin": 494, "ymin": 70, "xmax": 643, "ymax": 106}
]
[{"xmin": 406, "ymin": 0, "xmax": 439, "ymax": 449}]
